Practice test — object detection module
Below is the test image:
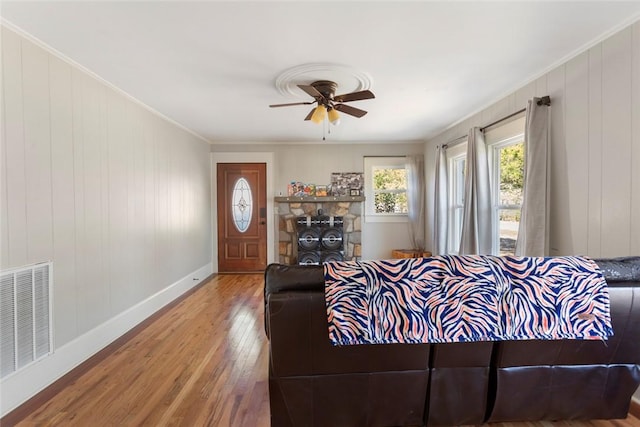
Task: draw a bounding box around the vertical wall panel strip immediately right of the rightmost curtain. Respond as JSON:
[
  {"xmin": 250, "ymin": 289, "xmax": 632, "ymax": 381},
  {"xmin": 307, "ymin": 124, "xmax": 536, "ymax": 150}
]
[{"xmin": 547, "ymin": 65, "xmax": 573, "ymax": 255}]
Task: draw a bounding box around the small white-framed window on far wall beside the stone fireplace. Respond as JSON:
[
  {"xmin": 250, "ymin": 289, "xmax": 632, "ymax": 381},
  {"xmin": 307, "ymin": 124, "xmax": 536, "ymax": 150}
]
[{"xmin": 364, "ymin": 157, "xmax": 408, "ymax": 222}]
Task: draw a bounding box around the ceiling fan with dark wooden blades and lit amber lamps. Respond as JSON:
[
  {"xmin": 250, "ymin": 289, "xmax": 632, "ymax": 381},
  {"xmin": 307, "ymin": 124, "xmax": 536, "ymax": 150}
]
[{"xmin": 269, "ymin": 80, "xmax": 375, "ymax": 125}]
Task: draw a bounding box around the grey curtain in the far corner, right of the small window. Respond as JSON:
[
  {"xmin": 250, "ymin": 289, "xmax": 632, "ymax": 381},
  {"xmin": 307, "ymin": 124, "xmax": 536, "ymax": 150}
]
[{"xmin": 406, "ymin": 155, "xmax": 425, "ymax": 250}]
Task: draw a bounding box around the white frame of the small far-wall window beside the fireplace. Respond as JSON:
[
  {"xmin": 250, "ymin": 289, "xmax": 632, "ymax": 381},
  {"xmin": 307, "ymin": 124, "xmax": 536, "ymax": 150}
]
[{"xmin": 364, "ymin": 156, "xmax": 409, "ymax": 222}]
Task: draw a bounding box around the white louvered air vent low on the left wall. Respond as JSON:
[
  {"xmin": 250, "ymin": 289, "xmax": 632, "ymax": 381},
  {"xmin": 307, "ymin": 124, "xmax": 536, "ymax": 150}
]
[{"xmin": 0, "ymin": 263, "xmax": 52, "ymax": 378}]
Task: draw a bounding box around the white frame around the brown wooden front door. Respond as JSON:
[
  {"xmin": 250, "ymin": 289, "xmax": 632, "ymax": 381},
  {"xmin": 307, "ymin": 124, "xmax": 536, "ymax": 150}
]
[{"xmin": 211, "ymin": 152, "xmax": 278, "ymax": 273}]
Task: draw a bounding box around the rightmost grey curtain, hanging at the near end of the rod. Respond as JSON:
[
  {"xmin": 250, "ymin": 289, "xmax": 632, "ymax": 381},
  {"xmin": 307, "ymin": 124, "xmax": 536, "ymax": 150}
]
[{"xmin": 515, "ymin": 98, "xmax": 550, "ymax": 256}]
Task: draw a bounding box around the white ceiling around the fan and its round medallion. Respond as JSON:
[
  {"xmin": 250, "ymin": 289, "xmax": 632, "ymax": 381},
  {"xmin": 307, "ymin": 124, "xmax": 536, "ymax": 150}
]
[{"xmin": 0, "ymin": 0, "xmax": 640, "ymax": 143}]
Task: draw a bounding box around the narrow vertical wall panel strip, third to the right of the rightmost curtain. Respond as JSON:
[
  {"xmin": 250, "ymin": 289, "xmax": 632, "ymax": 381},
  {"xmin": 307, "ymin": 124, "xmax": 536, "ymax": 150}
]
[{"xmin": 586, "ymin": 45, "xmax": 603, "ymax": 257}]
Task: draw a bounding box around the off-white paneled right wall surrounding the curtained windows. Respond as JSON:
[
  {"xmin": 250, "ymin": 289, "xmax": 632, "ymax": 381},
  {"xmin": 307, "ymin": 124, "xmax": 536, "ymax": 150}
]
[{"xmin": 426, "ymin": 22, "xmax": 640, "ymax": 257}]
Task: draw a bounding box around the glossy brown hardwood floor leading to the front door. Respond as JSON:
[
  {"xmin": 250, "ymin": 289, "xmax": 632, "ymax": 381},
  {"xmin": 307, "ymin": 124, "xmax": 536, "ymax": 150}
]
[{"xmin": 3, "ymin": 274, "xmax": 640, "ymax": 427}]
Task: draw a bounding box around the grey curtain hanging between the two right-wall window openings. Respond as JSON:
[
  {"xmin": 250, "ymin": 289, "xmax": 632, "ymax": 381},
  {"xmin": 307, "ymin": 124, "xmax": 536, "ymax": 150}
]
[{"xmin": 460, "ymin": 127, "xmax": 493, "ymax": 255}]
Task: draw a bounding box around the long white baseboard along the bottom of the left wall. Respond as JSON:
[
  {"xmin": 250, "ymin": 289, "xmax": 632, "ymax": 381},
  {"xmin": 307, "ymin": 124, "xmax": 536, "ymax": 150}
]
[{"xmin": 0, "ymin": 263, "xmax": 213, "ymax": 417}]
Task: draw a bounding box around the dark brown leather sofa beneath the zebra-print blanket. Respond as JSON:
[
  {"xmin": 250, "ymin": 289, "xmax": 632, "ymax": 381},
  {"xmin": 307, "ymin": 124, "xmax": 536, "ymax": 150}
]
[{"xmin": 264, "ymin": 257, "xmax": 640, "ymax": 427}]
